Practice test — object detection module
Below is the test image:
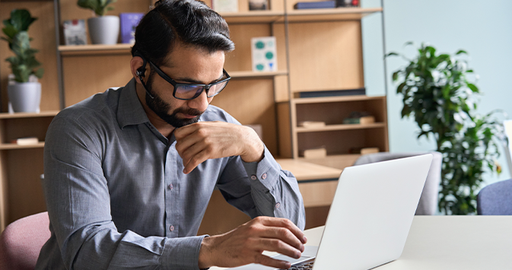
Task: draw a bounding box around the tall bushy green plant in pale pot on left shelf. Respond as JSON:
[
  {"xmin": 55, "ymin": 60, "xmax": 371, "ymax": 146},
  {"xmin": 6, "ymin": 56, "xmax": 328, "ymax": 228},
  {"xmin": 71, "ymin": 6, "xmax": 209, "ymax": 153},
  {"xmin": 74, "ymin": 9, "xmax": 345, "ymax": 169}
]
[{"xmin": 2, "ymin": 9, "xmax": 44, "ymax": 112}]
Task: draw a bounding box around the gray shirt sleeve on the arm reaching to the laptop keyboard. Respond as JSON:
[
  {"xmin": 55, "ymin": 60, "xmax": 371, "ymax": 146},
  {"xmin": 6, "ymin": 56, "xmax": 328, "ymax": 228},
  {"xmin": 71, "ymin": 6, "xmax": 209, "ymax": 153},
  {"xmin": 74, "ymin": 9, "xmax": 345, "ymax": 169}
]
[{"xmin": 40, "ymin": 116, "xmax": 205, "ymax": 269}]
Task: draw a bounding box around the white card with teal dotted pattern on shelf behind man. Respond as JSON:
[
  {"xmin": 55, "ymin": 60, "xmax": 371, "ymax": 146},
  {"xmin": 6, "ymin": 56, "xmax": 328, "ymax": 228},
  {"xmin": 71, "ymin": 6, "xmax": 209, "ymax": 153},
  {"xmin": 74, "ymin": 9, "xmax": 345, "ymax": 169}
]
[{"xmin": 251, "ymin": 37, "xmax": 277, "ymax": 72}]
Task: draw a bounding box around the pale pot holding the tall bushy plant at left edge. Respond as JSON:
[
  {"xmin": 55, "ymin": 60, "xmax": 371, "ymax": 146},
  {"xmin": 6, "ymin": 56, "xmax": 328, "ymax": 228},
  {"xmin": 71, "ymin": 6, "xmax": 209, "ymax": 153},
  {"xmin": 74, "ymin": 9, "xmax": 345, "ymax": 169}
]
[{"xmin": 7, "ymin": 82, "xmax": 41, "ymax": 112}]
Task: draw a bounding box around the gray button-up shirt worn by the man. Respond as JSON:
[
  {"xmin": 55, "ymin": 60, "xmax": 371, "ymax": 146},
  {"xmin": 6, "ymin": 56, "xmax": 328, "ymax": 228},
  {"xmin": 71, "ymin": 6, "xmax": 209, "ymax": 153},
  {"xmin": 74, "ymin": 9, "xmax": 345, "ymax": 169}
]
[{"xmin": 37, "ymin": 80, "xmax": 305, "ymax": 269}]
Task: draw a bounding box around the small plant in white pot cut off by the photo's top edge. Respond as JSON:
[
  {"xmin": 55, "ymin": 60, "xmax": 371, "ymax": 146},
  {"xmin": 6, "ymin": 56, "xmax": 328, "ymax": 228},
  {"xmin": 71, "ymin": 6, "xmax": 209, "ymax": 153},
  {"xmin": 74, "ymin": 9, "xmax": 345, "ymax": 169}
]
[{"xmin": 77, "ymin": 0, "xmax": 119, "ymax": 44}]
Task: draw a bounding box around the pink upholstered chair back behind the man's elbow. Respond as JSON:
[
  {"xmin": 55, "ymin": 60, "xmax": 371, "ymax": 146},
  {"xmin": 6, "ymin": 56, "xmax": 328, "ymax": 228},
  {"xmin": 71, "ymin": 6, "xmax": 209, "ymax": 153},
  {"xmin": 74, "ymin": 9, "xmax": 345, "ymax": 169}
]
[{"xmin": 0, "ymin": 212, "xmax": 50, "ymax": 270}]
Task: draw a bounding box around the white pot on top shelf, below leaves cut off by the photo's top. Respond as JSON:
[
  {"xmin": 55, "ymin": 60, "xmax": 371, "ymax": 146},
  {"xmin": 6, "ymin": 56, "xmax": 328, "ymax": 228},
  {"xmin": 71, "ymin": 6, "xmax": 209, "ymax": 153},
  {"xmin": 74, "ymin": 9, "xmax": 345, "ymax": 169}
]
[{"xmin": 87, "ymin": 16, "xmax": 119, "ymax": 44}]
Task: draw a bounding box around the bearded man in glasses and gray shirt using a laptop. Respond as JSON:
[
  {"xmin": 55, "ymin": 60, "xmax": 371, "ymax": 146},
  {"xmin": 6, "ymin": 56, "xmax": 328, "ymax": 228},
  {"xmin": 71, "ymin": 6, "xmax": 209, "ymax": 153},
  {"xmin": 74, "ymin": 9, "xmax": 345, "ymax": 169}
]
[{"xmin": 37, "ymin": 0, "xmax": 306, "ymax": 269}]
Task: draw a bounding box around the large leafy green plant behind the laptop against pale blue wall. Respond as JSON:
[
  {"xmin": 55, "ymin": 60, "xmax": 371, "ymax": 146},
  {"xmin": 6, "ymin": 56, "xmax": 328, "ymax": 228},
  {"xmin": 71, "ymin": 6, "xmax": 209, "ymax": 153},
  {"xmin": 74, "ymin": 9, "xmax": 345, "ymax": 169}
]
[{"xmin": 387, "ymin": 43, "xmax": 503, "ymax": 215}]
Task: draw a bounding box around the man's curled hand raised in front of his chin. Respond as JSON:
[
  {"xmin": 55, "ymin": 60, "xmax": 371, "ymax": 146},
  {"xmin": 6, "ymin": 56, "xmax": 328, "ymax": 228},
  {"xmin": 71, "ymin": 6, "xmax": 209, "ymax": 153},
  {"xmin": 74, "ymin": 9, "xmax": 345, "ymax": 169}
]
[{"xmin": 174, "ymin": 122, "xmax": 264, "ymax": 173}]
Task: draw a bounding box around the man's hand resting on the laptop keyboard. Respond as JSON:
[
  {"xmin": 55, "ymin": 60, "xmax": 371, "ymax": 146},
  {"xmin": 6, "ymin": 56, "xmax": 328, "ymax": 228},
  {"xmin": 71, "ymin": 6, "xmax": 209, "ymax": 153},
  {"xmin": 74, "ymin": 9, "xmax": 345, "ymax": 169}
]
[{"xmin": 199, "ymin": 216, "xmax": 306, "ymax": 269}]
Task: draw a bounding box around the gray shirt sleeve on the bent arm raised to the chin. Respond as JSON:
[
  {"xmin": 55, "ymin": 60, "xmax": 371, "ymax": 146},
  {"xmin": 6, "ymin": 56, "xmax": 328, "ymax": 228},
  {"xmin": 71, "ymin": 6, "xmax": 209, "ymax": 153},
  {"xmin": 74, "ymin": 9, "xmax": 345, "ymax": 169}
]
[{"xmin": 217, "ymin": 147, "xmax": 306, "ymax": 230}]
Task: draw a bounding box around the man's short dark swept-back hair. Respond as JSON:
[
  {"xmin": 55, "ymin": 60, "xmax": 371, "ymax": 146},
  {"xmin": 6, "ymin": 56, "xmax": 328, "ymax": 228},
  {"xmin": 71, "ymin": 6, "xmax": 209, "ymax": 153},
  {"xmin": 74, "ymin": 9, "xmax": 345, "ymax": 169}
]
[{"xmin": 132, "ymin": 0, "xmax": 235, "ymax": 65}]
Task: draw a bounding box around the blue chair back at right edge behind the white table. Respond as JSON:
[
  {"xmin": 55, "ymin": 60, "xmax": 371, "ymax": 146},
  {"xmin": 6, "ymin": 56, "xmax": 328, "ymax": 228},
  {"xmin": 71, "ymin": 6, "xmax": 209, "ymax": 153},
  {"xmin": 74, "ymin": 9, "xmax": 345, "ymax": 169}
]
[{"xmin": 476, "ymin": 179, "xmax": 512, "ymax": 215}]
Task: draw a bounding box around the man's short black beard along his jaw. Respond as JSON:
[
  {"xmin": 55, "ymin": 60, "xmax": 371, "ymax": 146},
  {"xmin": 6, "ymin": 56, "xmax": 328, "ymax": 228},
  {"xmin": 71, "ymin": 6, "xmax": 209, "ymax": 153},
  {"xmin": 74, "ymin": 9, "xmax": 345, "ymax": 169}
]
[{"xmin": 146, "ymin": 72, "xmax": 203, "ymax": 128}]
